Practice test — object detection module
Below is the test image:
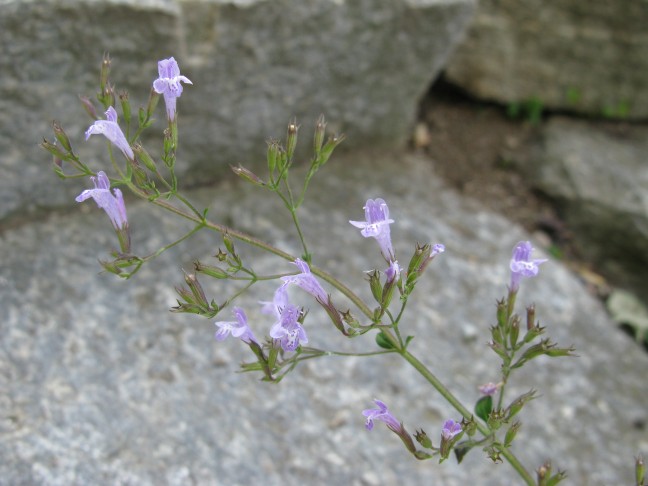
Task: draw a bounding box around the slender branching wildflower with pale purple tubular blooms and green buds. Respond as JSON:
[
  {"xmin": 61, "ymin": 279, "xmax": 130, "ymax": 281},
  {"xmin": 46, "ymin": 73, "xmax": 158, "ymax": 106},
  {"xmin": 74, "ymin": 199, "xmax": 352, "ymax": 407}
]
[{"xmin": 42, "ymin": 57, "xmax": 588, "ymax": 486}]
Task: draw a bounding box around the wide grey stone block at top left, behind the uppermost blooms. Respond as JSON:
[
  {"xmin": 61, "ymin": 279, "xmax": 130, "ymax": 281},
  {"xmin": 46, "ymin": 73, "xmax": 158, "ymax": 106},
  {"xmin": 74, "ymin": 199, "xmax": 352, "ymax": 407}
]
[{"xmin": 0, "ymin": 0, "xmax": 474, "ymax": 218}]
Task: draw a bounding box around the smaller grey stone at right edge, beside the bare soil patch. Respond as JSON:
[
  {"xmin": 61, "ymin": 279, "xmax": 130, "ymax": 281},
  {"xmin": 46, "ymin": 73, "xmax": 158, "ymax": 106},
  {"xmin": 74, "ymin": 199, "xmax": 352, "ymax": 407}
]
[{"xmin": 525, "ymin": 117, "xmax": 648, "ymax": 299}]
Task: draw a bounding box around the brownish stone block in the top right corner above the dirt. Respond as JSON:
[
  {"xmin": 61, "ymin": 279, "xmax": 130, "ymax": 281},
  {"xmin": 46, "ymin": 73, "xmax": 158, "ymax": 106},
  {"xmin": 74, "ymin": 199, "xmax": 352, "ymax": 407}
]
[{"xmin": 446, "ymin": 0, "xmax": 648, "ymax": 118}]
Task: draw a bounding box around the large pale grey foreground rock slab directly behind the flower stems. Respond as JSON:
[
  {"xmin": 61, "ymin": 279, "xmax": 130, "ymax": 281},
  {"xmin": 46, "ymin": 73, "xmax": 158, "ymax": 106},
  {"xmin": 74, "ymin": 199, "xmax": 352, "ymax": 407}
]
[{"xmin": 0, "ymin": 153, "xmax": 648, "ymax": 486}]
